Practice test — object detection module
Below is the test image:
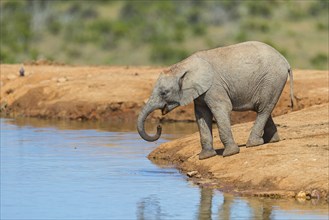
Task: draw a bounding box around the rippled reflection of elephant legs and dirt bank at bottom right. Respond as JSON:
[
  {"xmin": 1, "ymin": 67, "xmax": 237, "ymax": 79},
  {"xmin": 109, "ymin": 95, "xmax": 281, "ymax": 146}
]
[{"xmin": 198, "ymin": 187, "xmax": 329, "ymax": 220}]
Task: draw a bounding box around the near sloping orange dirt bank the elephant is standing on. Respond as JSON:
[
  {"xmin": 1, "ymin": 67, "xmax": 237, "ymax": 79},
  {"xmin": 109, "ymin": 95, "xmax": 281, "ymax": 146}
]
[{"xmin": 149, "ymin": 104, "xmax": 329, "ymax": 201}]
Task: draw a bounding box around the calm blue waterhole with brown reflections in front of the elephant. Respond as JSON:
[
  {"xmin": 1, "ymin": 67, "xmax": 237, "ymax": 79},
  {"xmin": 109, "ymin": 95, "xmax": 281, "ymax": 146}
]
[{"xmin": 0, "ymin": 119, "xmax": 328, "ymax": 220}]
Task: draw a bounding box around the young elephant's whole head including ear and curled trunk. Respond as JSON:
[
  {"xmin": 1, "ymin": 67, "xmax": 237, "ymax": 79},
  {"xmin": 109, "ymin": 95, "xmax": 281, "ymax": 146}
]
[{"xmin": 137, "ymin": 54, "xmax": 214, "ymax": 141}]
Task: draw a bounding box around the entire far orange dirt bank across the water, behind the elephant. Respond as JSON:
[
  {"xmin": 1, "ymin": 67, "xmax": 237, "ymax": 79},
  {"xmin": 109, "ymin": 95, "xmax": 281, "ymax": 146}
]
[{"xmin": 0, "ymin": 63, "xmax": 328, "ymax": 124}]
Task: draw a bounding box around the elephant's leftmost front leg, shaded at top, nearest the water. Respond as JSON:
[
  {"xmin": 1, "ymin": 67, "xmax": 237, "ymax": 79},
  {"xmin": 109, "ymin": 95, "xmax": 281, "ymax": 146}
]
[{"xmin": 194, "ymin": 100, "xmax": 217, "ymax": 160}]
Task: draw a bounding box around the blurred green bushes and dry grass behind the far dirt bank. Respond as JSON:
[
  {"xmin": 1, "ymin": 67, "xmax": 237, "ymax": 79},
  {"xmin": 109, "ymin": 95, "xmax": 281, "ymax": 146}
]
[{"xmin": 0, "ymin": 0, "xmax": 329, "ymax": 69}]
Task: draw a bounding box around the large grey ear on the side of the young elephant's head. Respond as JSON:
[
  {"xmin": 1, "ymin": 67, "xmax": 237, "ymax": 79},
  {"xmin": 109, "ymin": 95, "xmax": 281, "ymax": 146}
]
[{"xmin": 178, "ymin": 58, "xmax": 213, "ymax": 105}]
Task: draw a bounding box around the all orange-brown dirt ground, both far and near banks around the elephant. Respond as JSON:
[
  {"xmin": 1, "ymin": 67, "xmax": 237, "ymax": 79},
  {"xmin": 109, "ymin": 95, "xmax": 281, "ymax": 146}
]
[{"xmin": 0, "ymin": 62, "xmax": 329, "ymax": 200}]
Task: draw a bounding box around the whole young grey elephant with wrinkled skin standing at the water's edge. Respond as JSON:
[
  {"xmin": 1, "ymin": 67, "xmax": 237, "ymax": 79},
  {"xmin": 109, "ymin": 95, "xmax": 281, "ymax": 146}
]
[{"xmin": 137, "ymin": 42, "xmax": 293, "ymax": 159}]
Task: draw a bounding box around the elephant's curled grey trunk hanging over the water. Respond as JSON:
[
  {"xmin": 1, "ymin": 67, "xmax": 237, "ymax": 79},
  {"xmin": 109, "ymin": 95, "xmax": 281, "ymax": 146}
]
[{"xmin": 137, "ymin": 102, "xmax": 162, "ymax": 142}]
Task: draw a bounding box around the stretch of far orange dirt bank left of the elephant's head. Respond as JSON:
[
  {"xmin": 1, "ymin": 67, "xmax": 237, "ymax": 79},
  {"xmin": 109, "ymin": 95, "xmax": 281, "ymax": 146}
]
[{"xmin": 1, "ymin": 65, "xmax": 159, "ymax": 120}]
